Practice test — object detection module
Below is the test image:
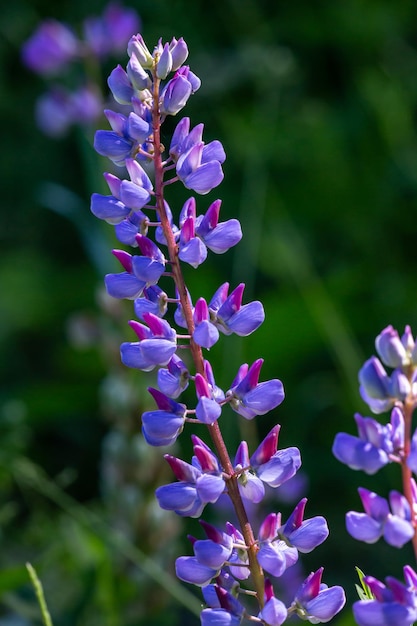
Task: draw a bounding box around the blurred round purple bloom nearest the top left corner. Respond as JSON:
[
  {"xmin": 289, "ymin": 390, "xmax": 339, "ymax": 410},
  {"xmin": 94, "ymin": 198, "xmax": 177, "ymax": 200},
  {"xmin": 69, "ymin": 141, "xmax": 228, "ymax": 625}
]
[{"xmin": 22, "ymin": 19, "xmax": 79, "ymax": 76}]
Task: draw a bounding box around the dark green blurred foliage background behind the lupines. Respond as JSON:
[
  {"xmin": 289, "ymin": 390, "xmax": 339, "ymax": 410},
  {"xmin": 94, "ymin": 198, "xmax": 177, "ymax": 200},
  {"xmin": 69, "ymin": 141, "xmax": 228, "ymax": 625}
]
[{"xmin": 0, "ymin": 0, "xmax": 417, "ymax": 626}]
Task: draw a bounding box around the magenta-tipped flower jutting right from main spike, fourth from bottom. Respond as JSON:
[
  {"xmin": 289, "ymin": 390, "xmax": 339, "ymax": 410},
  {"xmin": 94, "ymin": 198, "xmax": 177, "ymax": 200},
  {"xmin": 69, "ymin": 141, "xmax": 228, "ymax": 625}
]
[{"xmin": 226, "ymin": 359, "xmax": 284, "ymax": 420}]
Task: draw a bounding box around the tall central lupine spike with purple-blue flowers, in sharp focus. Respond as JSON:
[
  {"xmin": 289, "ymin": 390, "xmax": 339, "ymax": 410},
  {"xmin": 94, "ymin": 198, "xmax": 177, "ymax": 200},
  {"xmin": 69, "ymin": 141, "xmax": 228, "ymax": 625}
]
[{"xmin": 91, "ymin": 35, "xmax": 345, "ymax": 626}]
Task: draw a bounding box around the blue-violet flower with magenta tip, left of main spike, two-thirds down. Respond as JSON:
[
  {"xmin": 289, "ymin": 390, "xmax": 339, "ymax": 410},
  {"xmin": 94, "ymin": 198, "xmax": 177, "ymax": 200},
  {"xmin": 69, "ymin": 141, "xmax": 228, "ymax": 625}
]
[{"xmin": 142, "ymin": 387, "xmax": 187, "ymax": 446}]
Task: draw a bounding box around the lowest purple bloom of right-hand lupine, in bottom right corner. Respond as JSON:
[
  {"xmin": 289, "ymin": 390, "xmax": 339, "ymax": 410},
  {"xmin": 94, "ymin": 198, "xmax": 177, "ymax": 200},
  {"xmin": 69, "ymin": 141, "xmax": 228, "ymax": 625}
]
[{"xmin": 352, "ymin": 565, "xmax": 417, "ymax": 626}]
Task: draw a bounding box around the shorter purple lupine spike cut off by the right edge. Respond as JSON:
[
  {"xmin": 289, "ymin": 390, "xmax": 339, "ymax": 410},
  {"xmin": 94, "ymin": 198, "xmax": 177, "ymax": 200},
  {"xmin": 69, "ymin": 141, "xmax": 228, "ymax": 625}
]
[{"xmin": 333, "ymin": 325, "xmax": 417, "ymax": 626}]
